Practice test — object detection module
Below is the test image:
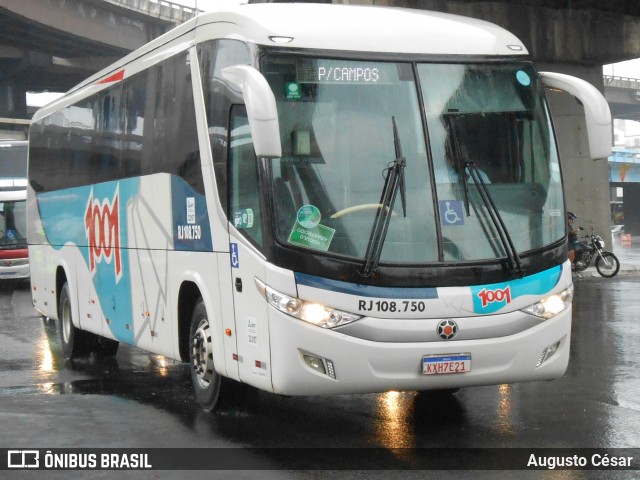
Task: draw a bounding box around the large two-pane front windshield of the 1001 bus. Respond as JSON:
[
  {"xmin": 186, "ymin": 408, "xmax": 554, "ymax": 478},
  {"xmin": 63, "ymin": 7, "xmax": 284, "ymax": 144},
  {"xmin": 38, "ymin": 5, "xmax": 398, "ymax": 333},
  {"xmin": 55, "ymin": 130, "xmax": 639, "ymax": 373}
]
[{"xmin": 262, "ymin": 54, "xmax": 565, "ymax": 263}]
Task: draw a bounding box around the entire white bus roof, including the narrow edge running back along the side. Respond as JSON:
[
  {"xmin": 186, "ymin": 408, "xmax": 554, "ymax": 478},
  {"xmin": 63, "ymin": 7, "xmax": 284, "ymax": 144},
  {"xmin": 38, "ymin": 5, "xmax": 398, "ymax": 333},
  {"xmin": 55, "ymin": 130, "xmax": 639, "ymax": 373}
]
[{"xmin": 34, "ymin": 3, "xmax": 528, "ymax": 120}]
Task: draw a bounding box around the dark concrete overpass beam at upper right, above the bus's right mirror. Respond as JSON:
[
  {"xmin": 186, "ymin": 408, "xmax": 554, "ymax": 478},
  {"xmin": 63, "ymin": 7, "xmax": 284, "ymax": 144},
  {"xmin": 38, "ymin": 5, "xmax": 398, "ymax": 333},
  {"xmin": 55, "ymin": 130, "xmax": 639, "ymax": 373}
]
[{"xmin": 348, "ymin": 0, "xmax": 640, "ymax": 65}]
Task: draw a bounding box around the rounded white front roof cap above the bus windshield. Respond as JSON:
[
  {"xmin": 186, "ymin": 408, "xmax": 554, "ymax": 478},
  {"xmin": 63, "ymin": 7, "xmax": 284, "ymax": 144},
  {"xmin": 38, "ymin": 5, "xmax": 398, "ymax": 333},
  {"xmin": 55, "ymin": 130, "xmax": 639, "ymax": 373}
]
[{"xmin": 198, "ymin": 3, "xmax": 527, "ymax": 55}]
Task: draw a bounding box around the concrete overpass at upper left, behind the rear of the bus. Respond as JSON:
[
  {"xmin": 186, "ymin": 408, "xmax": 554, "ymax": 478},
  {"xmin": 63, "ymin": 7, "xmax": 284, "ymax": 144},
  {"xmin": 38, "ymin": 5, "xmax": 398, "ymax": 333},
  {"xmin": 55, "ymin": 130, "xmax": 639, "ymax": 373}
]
[{"xmin": 0, "ymin": 0, "xmax": 195, "ymax": 118}]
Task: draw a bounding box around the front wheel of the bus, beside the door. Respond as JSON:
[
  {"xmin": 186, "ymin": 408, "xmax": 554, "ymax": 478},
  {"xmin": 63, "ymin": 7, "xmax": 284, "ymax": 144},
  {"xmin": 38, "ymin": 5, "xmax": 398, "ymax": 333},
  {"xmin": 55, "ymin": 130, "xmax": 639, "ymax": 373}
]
[{"xmin": 189, "ymin": 298, "xmax": 222, "ymax": 412}]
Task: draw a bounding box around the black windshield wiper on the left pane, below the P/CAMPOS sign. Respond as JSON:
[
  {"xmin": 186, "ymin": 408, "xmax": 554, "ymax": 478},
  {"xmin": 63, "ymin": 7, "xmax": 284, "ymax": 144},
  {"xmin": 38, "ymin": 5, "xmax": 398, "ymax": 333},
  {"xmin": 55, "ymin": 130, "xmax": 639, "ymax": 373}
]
[{"xmin": 361, "ymin": 117, "xmax": 407, "ymax": 277}]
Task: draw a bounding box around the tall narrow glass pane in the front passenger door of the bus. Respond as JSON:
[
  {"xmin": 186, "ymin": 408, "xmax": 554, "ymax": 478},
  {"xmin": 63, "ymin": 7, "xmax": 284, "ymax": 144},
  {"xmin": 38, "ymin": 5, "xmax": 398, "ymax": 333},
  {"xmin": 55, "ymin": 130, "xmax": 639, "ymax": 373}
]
[{"xmin": 229, "ymin": 106, "xmax": 263, "ymax": 247}]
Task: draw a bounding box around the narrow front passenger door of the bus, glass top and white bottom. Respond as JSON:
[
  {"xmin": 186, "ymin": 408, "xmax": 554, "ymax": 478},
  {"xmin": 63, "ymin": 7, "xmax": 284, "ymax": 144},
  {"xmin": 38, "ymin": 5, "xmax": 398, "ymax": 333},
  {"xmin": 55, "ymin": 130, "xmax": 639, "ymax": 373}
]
[{"xmin": 228, "ymin": 106, "xmax": 272, "ymax": 390}]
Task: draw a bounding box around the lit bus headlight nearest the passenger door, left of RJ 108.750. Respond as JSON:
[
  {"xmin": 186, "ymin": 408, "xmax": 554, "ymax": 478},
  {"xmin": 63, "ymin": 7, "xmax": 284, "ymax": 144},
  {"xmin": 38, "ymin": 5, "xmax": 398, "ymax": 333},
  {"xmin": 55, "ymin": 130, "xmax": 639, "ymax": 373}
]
[{"xmin": 255, "ymin": 278, "xmax": 362, "ymax": 328}]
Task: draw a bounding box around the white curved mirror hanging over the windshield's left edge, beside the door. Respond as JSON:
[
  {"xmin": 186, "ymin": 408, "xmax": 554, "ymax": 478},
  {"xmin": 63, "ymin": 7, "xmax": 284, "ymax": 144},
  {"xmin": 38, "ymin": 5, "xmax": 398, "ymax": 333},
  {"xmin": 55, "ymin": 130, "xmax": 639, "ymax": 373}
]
[{"xmin": 222, "ymin": 65, "xmax": 282, "ymax": 158}]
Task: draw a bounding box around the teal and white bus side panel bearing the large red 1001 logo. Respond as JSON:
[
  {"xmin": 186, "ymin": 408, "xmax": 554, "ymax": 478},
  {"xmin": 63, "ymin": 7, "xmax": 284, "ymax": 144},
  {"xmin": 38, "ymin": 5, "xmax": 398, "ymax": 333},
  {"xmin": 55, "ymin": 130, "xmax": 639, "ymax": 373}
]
[{"xmin": 38, "ymin": 179, "xmax": 139, "ymax": 345}]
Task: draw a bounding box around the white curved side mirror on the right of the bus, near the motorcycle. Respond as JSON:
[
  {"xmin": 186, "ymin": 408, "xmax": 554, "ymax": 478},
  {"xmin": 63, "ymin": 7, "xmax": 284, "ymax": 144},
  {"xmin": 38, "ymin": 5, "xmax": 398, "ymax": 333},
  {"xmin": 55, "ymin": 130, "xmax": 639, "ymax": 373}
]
[{"xmin": 540, "ymin": 72, "xmax": 613, "ymax": 160}]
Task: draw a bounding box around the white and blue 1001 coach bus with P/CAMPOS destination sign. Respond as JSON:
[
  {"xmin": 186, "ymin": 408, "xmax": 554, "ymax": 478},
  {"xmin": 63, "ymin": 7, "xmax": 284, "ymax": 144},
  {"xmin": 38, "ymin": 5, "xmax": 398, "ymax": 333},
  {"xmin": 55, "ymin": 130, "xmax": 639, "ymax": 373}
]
[{"xmin": 28, "ymin": 4, "xmax": 611, "ymax": 410}]
